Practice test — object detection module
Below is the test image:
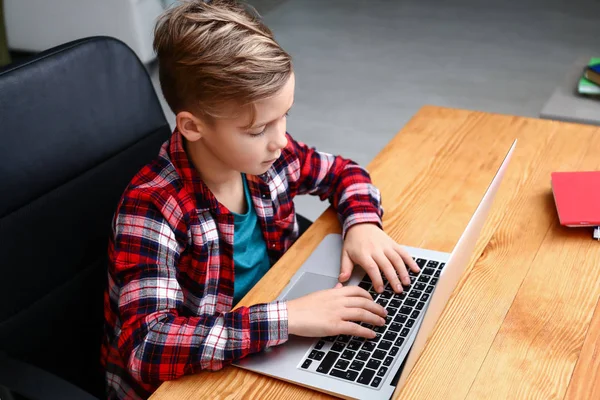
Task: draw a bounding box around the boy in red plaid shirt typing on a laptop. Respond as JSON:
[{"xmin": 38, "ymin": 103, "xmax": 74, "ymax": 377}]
[{"xmin": 102, "ymin": 0, "xmax": 418, "ymax": 398}]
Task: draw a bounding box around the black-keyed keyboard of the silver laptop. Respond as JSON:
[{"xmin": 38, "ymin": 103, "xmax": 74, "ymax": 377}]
[{"xmin": 299, "ymin": 257, "xmax": 446, "ymax": 388}]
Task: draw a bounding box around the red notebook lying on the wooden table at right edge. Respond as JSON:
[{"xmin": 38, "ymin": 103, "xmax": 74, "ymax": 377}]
[{"xmin": 552, "ymin": 171, "xmax": 600, "ymax": 226}]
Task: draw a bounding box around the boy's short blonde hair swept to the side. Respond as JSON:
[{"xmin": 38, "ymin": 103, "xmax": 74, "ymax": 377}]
[{"xmin": 154, "ymin": 0, "xmax": 292, "ymax": 126}]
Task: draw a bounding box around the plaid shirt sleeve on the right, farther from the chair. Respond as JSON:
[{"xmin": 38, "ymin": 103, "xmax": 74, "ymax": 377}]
[{"xmin": 284, "ymin": 134, "xmax": 383, "ymax": 237}]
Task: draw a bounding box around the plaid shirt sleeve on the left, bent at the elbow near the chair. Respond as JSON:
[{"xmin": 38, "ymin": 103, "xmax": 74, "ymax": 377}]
[{"xmin": 109, "ymin": 189, "xmax": 288, "ymax": 384}]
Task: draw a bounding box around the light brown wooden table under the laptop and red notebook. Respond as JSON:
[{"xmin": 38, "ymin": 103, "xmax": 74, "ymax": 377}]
[{"xmin": 152, "ymin": 106, "xmax": 600, "ymax": 400}]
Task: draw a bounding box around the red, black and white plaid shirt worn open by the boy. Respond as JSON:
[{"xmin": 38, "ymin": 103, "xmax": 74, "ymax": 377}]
[{"xmin": 102, "ymin": 130, "xmax": 382, "ymax": 398}]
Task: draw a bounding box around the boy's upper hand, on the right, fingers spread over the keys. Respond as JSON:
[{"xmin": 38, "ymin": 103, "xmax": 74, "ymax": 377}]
[{"xmin": 339, "ymin": 223, "xmax": 420, "ymax": 293}]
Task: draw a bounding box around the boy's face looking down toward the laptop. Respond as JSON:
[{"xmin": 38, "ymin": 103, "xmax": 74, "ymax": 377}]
[{"xmin": 178, "ymin": 74, "xmax": 295, "ymax": 175}]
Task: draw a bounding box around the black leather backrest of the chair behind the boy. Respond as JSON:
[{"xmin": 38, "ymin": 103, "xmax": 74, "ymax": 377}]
[{"xmin": 0, "ymin": 37, "xmax": 170, "ymax": 395}]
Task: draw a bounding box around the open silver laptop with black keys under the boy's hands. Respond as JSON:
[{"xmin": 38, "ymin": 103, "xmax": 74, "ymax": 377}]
[{"xmin": 234, "ymin": 140, "xmax": 517, "ymax": 399}]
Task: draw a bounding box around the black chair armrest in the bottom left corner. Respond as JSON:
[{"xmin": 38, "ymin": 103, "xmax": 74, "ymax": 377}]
[{"xmin": 0, "ymin": 353, "xmax": 98, "ymax": 400}]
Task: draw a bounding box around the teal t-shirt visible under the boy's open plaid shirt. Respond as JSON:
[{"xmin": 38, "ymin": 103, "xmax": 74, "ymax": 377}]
[{"xmin": 232, "ymin": 174, "xmax": 271, "ymax": 304}]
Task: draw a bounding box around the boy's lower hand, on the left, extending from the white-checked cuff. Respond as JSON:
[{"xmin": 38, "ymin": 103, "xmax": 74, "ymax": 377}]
[{"xmin": 287, "ymin": 283, "xmax": 387, "ymax": 339}]
